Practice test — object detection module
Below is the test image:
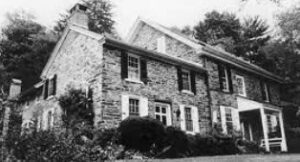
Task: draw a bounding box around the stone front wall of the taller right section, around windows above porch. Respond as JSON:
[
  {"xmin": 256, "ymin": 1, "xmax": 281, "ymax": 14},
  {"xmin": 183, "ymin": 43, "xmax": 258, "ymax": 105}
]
[{"xmin": 205, "ymin": 59, "xmax": 280, "ymax": 122}]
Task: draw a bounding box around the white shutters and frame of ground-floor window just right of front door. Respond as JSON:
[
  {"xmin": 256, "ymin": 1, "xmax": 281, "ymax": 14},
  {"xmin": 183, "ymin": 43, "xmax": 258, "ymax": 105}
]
[{"xmin": 179, "ymin": 105, "xmax": 200, "ymax": 134}]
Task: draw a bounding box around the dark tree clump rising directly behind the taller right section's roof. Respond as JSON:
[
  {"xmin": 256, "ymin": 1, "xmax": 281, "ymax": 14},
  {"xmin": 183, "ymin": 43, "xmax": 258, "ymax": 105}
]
[{"xmin": 194, "ymin": 11, "xmax": 270, "ymax": 65}]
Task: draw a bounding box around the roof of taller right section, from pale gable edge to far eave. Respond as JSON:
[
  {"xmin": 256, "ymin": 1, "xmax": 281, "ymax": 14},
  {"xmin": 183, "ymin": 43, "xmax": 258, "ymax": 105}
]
[{"xmin": 126, "ymin": 17, "xmax": 284, "ymax": 83}]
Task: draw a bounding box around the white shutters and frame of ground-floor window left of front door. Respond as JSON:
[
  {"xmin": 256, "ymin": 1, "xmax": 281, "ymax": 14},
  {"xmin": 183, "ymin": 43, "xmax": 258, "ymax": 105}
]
[{"xmin": 121, "ymin": 94, "xmax": 149, "ymax": 120}]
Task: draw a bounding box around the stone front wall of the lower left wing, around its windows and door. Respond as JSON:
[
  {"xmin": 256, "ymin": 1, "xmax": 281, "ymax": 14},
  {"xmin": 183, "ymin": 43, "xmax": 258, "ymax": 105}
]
[{"xmin": 102, "ymin": 48, "xmax": 211, "ymax": 133}]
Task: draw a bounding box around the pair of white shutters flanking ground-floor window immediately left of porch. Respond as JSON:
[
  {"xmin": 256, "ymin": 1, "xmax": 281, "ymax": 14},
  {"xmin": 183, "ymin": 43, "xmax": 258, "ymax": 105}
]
[{"xmin": 220, "ymin": 106, "xmax": 241, "ymax": 134}]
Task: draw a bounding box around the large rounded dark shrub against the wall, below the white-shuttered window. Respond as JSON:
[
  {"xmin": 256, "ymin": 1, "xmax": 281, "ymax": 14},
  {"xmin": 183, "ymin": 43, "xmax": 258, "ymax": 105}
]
[{"xmin": 118, "ymin": 117, "xmax": 166, "ymax": 154}]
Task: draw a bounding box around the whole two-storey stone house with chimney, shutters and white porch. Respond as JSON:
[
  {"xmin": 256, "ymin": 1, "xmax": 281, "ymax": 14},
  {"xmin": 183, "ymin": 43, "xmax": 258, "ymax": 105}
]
[{"xmin": 12, "ymin": 5, "xmax": 287, "ymax": 151}]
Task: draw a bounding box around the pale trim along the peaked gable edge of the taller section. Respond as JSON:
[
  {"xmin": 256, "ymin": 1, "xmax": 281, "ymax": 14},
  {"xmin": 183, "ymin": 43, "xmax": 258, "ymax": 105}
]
[{"xmin": 125, "ymin": 17, "xmax": 202, "ymax": 49}]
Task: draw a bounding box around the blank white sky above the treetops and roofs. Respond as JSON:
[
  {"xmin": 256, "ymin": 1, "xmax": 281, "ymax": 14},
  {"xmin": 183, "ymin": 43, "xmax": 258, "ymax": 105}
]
[{"xmin": 0, "ymin": 0, "xmax": 299, "ymax": 37}]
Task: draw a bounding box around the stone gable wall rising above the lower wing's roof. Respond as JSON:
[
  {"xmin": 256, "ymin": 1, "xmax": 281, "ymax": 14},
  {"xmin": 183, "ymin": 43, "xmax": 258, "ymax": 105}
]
[{"xmin": 130, "ymin": 25, "xmax": 202, "ymax": 64}]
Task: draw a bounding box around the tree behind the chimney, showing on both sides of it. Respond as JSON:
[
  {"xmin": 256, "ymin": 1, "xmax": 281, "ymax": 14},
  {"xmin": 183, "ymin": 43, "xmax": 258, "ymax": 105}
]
[{"xmin": 54, "ymin": 0, "xmax": 117, "ymax": 37}]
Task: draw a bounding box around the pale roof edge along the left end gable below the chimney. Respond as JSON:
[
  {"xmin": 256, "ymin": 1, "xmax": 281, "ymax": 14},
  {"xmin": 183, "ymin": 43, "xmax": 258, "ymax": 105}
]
[{"xmin": 41, "ymin": 24, "xmax": 104, "ymax": 79}]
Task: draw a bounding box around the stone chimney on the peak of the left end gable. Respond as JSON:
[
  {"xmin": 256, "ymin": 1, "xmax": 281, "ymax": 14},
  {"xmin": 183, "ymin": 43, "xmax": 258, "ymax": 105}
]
[{"xmin": 68, "ymin": 3, "xmax": 89, "ymax": 29}]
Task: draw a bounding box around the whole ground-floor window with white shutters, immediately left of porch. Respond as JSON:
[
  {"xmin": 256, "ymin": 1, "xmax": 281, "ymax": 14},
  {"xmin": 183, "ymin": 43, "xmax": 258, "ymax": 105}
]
[{"xmin": 220, "ymin": 106, "xmax": 240, "ymax": 134}]
